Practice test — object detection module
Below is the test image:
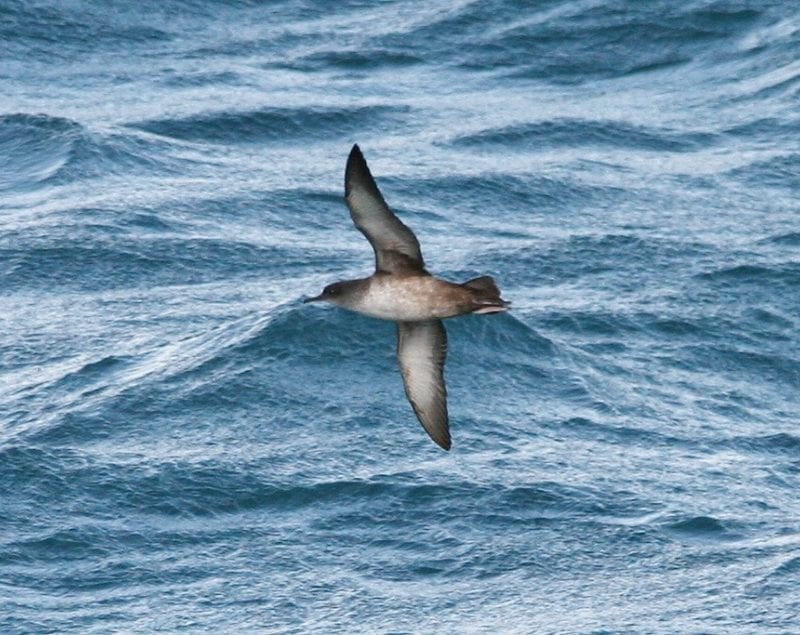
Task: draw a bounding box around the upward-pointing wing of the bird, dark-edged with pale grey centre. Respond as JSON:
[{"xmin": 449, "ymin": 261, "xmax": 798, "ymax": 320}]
[{"xmin": 344, "ymin": 145, "xmax": 425, "ymax": 273}]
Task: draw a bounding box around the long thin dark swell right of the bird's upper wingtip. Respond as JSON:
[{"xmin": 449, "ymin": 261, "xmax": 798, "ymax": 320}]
[{"xmin": 453, "ymin": 119, "xmax": 717, "ymax": 152}]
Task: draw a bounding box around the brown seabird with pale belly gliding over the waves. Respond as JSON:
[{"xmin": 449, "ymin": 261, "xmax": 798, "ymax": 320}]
[{"xmin": 305, "ymin": 144, "xmax": 511, "ymax": 450}]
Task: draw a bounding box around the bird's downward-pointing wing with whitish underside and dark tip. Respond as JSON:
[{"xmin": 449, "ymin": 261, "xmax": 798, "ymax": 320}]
[{"xmin": 397, "ymin": 320, "xmax": 450, "ymax": 450}]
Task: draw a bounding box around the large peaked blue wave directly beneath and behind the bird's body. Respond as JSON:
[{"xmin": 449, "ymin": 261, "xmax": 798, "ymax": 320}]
[{"xmin": 4, "ymin": 303, "xmax": 557, "ymax": 452}]
